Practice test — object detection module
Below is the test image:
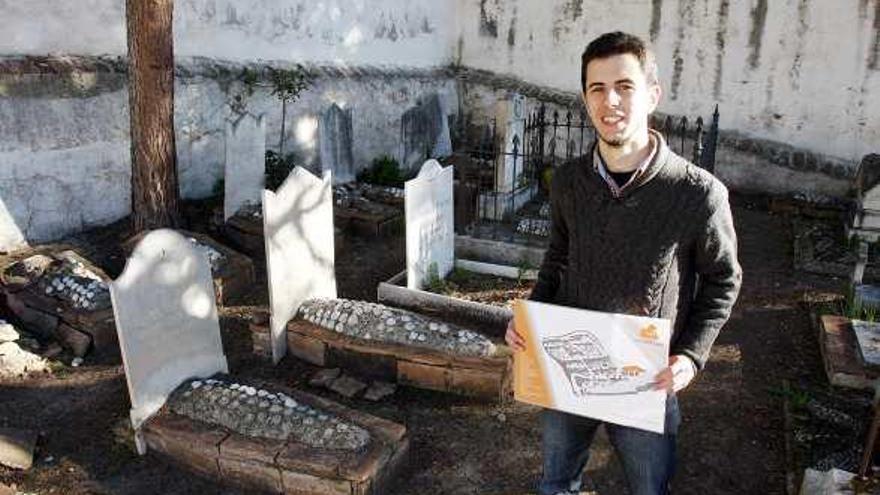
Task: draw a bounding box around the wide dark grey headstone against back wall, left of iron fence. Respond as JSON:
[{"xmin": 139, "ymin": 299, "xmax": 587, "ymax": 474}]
[{"xmin": 400, "ymin": 93, "xmax": 452, "ymax": 170}]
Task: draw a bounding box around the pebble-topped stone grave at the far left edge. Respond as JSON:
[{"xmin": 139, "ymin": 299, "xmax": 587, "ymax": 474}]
[{"xmin": 0, "ymin": 250, "xmax": 118, "ymax": 357}]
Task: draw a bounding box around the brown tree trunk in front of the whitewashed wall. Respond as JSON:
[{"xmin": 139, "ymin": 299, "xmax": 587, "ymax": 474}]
[{"xmin": 125, "ymin": 0, "xmax": 178, "ymax": 232}]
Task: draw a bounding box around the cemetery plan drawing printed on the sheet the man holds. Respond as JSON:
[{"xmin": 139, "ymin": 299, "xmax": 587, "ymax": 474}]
[{"xmin": 541, "ymin": 330, "xmax": 650, "ymax": 397}]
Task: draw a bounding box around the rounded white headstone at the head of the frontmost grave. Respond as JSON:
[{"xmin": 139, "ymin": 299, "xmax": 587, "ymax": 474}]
[{"xmin": 110, "ymin": 229, "xmax": 228, "ymax": 454}]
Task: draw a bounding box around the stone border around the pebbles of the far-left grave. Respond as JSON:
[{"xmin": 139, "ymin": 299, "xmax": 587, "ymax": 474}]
[{"xmin": 0, "ymin": 250, "xmax": 120, "ymax": 359}]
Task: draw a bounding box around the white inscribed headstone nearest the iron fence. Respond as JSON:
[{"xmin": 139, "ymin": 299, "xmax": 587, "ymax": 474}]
[{"xmin": 404, "ymin": 160, "xmax": 455, "ymax": 289}]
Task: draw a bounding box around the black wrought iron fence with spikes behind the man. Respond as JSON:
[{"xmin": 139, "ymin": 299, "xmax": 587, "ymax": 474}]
[{"xmin": 455, "ymin": 105, "xmax": 719, "ymax": 245}]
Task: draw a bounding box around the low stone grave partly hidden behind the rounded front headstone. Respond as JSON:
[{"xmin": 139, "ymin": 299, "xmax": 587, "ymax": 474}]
[{"xmin": 123, "ymin": 230, "xmax": 256, "ymax": 306}]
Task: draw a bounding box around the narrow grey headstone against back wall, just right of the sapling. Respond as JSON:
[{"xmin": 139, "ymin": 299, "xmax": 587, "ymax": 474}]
[{"xmin": 318, "ymin": 103, "xmax": 354, "ymax": 182}]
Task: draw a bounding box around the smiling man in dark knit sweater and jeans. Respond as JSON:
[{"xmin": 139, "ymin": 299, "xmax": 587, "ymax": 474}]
[{"xmin": 505, "ymin": 32, "xmax": 742, "ymax": 495}]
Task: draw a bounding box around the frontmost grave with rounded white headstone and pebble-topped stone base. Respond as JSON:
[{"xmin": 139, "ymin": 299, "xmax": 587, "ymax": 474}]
[{"xmin": 111, "ymin": 230, "xmax": 408, "ymax": 494}]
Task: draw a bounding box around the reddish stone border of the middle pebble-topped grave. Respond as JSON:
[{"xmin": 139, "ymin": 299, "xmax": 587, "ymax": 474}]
[{"xmin": 250, "ymin": 319, "xmax": 513, "ymax": 402}]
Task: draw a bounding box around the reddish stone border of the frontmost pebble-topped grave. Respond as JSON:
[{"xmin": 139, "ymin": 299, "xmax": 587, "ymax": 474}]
[{"xmin": 142, "ymin": 382, "xmax": 409, "ymax": 495}]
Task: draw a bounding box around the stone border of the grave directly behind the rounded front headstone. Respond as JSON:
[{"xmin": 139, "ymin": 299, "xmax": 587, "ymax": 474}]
[{"xmin": 123, "ymin": 229, "xmax": 257, "ymax": 306}]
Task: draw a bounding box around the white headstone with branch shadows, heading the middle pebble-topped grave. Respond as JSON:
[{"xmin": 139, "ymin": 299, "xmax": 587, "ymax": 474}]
[{"xmin": 263, "ymin": 167, "xmax": 336, "ymax": 363}]
